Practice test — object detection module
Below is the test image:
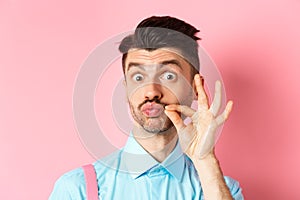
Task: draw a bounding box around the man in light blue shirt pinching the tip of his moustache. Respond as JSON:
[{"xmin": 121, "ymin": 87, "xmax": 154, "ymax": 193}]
[{"xmin": 50, "ymin": 17, "xmax": 243, "ymax": 200}]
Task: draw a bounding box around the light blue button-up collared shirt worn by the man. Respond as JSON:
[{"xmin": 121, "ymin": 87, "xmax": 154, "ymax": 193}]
[{"xmin": 49, "ymin": 135, "xmax": 244, "ymax": 200}]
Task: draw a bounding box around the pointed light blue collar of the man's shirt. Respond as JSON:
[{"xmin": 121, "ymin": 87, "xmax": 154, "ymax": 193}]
[{"xmin": 120, "ymin": 134, "xmax": 185, "ymax": 181}]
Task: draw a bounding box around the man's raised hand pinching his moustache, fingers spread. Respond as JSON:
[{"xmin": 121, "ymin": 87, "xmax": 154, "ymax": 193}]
[{"xmin": 165, "ymin": 74, "xmax": 233, "ymax": 160}]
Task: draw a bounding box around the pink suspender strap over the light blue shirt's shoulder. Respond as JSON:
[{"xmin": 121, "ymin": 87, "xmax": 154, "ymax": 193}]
[{"xmin": 82, "ymin": 164, "xmax": 99, "ymax": 200}]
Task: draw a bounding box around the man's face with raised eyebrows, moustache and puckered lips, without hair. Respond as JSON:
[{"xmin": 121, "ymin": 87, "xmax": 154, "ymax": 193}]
[{"xmin": 125, "ymin": 48, "xmax": 193, "ymax": 133}]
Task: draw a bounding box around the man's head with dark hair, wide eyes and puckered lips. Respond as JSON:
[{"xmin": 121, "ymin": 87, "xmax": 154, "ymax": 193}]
[{"xmin": 119, "ymin": 17, "xmax": 199, "ymax": 133}]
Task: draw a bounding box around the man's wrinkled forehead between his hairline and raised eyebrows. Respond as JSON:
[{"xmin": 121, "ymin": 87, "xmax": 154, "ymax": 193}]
[{"xmin": 125, "ymin": 48, "xmax": 188, "ymax": 71}]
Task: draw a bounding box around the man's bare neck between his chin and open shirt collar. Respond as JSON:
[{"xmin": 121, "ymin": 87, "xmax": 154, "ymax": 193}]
[{"xmin": 133, "ymin": 127, "xmax": 178, "ymax": 162}]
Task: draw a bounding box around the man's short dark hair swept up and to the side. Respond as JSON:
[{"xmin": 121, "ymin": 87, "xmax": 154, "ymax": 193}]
[{"xmin": 119, "ymin": 16, "xmax": 200, "ymax": 76}]
